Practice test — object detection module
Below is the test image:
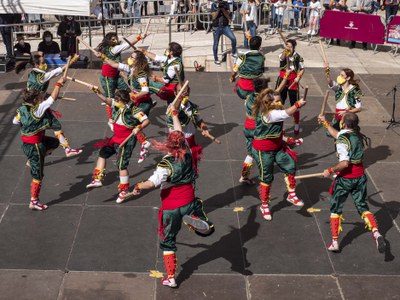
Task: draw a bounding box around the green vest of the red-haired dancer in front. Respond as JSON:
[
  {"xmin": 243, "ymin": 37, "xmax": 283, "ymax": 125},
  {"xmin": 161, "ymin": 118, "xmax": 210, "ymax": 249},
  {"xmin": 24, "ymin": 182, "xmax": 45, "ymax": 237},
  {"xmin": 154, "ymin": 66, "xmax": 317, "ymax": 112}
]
[{"xmin": 157, "ymin": 150, "xmax": 197, "ymax": 185}]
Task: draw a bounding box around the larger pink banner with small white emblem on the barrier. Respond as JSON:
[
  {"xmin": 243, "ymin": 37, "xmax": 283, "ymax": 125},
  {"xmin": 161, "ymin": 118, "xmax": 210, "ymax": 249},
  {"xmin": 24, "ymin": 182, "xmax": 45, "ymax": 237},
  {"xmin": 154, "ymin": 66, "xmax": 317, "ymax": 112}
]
[{"xmin": 320, "ymin": 10, "xmax": 385, "ymax": 44}]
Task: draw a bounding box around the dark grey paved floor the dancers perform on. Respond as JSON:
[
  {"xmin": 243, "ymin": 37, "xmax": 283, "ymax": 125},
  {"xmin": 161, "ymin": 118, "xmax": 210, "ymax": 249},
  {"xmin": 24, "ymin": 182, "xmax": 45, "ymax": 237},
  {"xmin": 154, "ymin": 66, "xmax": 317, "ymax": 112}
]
[{"xmin": 0, "ymin": 33, "xmax": 400, "ymax": 300}]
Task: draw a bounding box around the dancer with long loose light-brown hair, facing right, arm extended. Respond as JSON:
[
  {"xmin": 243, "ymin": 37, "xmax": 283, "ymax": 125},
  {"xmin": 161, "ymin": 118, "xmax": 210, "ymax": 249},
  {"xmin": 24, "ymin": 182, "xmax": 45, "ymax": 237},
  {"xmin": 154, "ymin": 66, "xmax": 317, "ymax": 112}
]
[{"xmin": 252, "ymin": 89, "xmax": 306, "ymax": 221}]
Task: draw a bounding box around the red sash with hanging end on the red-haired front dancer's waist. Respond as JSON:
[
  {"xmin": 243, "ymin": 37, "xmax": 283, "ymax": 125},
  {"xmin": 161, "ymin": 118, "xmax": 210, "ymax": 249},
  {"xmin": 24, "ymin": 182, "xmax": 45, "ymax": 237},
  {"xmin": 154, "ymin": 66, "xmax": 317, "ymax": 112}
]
[{"xmin": 158, "ymin": 183, "xmax": 195, "ymax": 239}]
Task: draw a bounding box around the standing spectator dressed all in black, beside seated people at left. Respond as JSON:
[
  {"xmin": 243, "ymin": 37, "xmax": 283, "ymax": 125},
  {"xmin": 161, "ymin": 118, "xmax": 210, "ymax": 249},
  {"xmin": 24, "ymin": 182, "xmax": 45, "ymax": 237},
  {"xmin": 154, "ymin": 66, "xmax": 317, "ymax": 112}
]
[{"xmin": 57, "ymin": 16, "xmax": 82, "ymax": 56}]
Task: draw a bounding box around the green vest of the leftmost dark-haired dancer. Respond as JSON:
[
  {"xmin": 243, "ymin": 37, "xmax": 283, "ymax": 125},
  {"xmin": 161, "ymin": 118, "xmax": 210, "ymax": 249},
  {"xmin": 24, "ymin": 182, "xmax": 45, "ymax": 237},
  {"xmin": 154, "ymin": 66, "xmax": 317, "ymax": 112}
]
[{"xmin": 17, "ymin": 103, "xmax": 55, "ymax": 136}]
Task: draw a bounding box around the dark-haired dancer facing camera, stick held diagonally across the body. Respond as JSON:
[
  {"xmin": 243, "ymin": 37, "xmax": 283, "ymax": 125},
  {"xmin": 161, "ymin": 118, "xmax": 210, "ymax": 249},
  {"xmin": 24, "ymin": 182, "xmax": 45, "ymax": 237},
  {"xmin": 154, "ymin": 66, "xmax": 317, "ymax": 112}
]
[{"xmin": 86, "ymin": 86, "xmax": 150, "ymax": 203}]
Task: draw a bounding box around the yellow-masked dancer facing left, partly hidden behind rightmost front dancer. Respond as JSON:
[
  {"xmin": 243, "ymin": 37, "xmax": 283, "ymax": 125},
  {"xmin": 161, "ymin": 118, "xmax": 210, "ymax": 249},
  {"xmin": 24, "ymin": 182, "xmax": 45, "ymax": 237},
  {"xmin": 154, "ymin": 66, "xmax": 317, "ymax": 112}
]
[{"xmin": 325, "ymin": 64, "xmax": 363, "ymax": 131}]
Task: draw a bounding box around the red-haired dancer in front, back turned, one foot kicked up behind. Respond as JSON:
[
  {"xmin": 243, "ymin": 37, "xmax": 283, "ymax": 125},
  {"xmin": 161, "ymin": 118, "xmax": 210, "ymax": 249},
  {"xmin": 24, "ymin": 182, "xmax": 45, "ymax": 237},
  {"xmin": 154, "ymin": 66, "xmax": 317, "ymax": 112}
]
[{"xmin": 133, "ymin": 103, "xmax": 214, "ymax": 288}]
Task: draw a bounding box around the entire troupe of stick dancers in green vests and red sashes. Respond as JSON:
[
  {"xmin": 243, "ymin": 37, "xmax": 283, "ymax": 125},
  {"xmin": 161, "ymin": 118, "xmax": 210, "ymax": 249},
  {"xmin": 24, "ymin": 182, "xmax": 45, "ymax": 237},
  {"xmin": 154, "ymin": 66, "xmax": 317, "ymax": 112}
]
[{"xmin": 13, "ymin": 33, "xmax": 385, "ymax": 287}]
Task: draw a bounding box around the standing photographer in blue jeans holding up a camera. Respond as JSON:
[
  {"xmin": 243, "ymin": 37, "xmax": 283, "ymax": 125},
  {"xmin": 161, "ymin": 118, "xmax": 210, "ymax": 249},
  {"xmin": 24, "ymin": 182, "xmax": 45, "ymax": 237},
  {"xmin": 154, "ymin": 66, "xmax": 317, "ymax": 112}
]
[{"xmin": 211, "ymin": 0, "xmax": 237, "ymax": 65}]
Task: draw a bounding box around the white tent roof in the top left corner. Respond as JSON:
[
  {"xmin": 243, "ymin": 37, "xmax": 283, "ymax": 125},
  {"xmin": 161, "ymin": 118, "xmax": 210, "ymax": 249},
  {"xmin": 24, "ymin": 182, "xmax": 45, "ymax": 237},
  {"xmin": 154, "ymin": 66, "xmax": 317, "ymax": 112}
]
[{"xmin": 0, "ymin": 0, "xmax": 98, "ymax": 16}]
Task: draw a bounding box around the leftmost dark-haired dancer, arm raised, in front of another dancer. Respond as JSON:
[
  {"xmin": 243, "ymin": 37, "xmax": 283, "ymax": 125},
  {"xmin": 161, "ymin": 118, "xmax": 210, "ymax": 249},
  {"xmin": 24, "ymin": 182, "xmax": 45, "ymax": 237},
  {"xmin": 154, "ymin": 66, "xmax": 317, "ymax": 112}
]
[{"xmin": 13, "ymin": 77, "xmax": 65, "ymax": 210}]
